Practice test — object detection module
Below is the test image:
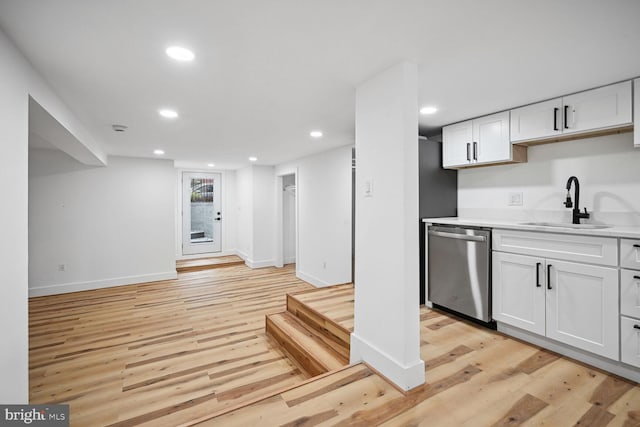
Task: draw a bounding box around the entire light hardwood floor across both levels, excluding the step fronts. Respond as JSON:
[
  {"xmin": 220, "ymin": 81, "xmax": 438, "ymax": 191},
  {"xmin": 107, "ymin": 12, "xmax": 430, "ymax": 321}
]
[{"xmin": 30, "ymin": 266, "xmax": 640, "ymax": 427}]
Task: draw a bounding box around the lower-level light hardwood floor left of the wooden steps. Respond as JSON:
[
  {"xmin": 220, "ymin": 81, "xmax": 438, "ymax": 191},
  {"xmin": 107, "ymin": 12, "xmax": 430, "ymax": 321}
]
[{"xmin": 29, "ymin": 265, "xmax": 312, "ymax": 426}]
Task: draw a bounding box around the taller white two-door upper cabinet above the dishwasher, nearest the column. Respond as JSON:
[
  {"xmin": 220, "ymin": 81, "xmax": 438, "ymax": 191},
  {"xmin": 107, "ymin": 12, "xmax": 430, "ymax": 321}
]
[{"xmin": 442, "ymin": 111, "xmax": 512, "ymax": 168}]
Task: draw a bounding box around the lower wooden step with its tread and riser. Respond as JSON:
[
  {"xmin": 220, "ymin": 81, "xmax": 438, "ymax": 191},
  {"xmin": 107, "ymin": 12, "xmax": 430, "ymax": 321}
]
[{"xmin": 266, "ymin": 311, "xmax": 349, "ymax": 376}]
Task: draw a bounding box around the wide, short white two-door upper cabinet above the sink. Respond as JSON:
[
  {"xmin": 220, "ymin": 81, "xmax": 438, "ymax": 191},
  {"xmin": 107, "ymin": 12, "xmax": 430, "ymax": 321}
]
[{"xmin": 511, "ymin": 81, "xmax": 632, "ymax": 142}]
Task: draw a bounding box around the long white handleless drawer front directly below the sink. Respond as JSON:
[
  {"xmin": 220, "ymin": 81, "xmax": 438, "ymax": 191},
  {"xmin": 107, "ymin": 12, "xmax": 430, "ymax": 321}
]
[{"xmin": 493, "ymin": 229, "xmax": 618, "ymax": 267}]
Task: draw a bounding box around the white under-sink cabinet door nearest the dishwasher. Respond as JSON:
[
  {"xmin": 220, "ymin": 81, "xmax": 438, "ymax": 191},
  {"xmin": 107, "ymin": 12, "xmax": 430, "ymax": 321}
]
[{"xmin": 492, "ymin": 252, "xmax": 545, "ymax": 335}]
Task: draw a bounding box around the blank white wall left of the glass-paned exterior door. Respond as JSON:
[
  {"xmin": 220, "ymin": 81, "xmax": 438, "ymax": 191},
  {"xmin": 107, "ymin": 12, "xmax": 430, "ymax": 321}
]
[{"xmin": 29, "ymin": 154, "xmax": 176, "ymax": 296}]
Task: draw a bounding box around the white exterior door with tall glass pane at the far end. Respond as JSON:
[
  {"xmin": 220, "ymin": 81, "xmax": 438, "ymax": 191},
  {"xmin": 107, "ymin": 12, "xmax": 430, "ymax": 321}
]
[{"xmin": 182, "ymin": 172, "xmax": 222, "ymax": 255}]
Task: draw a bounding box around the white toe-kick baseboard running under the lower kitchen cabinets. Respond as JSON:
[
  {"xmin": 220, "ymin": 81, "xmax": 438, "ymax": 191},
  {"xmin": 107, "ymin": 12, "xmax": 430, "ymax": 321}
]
[{"xmin": 498, "ymin": 322, "xmax": 640, "ymax": 382}]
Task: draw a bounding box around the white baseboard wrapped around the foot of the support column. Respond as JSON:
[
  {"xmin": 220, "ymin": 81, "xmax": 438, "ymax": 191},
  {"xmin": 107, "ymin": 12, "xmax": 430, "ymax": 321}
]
[{"xmin": 350, "ymin": 332, "xmax": 425, "ymax": 391}]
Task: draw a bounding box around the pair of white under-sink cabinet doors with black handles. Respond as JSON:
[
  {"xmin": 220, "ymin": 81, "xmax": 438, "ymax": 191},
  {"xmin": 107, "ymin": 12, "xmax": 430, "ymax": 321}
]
[{"xmin": 492, "ymin": 236, "xmax": 619, "ymax": 360}]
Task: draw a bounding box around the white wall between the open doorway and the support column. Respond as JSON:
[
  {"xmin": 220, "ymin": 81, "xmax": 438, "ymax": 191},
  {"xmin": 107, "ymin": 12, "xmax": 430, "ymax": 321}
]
[{"xmin": 275, "ymin": 146, "xmax": 352, "ymax": 286}]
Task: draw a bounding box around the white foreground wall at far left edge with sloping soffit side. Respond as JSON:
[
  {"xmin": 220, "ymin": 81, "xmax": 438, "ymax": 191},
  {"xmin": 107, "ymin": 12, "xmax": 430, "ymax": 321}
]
[{"xmin": 0, "ymin": 27, "xmax": 106, "ymax": 404}]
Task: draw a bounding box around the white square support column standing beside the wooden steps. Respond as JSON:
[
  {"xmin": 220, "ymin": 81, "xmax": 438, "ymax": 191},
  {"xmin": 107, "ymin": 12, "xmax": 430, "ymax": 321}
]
[{"xmin": 351, "ymin": 63, "xmax": 425, "ymax": 390}]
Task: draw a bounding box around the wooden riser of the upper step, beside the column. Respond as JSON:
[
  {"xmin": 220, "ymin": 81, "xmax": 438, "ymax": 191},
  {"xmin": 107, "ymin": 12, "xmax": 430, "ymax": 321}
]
[{"xmin": 287, "ymin": 294, "xmax": 351, "ymax": 360}]
